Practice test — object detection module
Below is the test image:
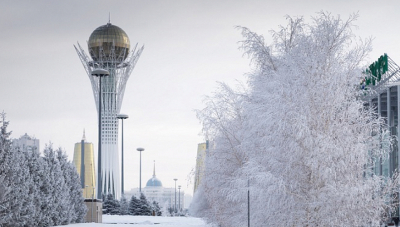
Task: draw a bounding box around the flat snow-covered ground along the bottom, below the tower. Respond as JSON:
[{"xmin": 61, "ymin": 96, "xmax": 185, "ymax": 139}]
[{"xmin": 67, "ymin": 215, "xmax": 212, "ymax": 227}]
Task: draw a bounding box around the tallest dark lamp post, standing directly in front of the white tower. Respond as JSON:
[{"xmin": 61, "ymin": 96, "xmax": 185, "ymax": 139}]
[{"xmin": 91, "ymin": 69, "xmax": 110, "ymax": 199}]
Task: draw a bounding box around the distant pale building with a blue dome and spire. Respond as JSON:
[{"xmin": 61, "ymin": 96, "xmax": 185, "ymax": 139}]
[{"xmin": 125, "ymin": 161, "xmax": 185, "ymax": 210}]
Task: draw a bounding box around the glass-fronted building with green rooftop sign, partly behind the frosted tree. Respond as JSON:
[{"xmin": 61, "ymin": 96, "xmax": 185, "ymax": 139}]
[{"xmin": 361, "ymin": 54, "xmax": 400, "ymax": 220}]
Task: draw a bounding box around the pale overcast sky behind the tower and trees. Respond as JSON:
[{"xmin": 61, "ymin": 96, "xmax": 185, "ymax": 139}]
[{"xmin": 0, "ymin": 0, "xmax": 400, "ymax": 194}]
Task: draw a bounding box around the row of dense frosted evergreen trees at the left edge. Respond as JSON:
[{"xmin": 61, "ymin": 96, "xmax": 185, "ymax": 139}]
[{"xmin": 0, "ymin": 113, "xmax": 87, "ymax": 227}]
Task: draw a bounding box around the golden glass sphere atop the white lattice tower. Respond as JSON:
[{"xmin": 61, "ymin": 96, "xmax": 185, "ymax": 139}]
[{"xmin": 88, "ymin": 23, "xmax": 131, "ymax": 61}]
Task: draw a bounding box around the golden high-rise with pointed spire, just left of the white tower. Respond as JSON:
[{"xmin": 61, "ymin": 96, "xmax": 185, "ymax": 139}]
[{"xmin": 73, "ymin": 131, "xmax": 96, "ymax": 198}]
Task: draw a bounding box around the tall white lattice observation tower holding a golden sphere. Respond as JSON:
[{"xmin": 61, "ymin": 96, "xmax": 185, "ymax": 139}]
[{"xmin": 74, "ymin": 22, "xmax": 144, "ymax": 199}]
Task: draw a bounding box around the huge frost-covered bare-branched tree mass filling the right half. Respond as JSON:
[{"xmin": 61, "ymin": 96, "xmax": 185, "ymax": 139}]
[{"xmin": 193, "ymin": 12, "xmax": 398, "ymax": 227}]
